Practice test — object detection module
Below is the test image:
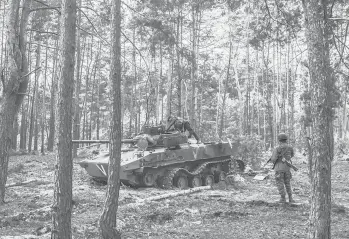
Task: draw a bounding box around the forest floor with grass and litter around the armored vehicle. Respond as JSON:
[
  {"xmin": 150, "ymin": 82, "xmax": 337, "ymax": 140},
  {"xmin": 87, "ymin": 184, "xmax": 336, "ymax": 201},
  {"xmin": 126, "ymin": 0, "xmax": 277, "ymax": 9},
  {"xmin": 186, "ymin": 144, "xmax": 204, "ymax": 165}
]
[{"xmin": 0, "ymin": 148, "xmax": 349, "ymax": 239}]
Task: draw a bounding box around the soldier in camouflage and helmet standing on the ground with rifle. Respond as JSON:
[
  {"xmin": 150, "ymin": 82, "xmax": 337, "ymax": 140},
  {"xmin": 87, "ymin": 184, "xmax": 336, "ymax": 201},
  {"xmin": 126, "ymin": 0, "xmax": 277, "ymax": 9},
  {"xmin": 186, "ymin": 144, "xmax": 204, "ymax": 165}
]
[{"xmin": 270, "ymin": 133, "xmax": 295, "ymax": 203}]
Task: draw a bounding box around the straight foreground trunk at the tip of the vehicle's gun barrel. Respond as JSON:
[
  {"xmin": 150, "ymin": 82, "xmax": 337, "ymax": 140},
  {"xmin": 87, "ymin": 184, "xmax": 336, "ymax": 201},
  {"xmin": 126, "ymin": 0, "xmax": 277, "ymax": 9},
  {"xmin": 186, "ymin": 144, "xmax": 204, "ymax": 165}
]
[{"xmin": 51, "ymin": 0, "xmax": 76, "ymax": 236}]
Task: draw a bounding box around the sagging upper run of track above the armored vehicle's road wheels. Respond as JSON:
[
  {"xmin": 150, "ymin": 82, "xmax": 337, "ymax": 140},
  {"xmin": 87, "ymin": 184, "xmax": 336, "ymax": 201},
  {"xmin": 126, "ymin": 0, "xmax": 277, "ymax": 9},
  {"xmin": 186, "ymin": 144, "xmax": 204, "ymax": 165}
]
[{"xmin": 159, "ymin": 158, "xmax": 231, "ymax": 189}]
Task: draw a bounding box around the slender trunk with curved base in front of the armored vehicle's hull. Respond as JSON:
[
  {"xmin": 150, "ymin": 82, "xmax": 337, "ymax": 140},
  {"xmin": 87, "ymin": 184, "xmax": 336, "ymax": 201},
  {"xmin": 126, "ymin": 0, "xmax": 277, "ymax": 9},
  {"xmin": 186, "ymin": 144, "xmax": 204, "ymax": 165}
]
[{"xmin": 99, "ymin": 0, "xmax": 122, "ymax": 239}]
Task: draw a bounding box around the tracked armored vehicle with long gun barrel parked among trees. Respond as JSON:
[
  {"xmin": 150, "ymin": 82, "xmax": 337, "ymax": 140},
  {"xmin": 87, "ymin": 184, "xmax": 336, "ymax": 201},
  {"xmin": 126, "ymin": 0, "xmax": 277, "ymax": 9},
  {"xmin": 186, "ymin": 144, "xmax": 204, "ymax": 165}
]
[{"xmin": 75, "ymin": 126, "xmax": 243, "ymax": 189}]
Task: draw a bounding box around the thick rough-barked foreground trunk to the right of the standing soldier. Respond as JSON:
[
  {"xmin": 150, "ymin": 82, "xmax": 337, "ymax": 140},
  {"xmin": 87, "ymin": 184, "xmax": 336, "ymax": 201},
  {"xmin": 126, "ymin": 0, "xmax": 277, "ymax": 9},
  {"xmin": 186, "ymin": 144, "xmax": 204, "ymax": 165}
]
[{"xmin": 303, "ymin": 0, "xmax": 338, "ymax": 239}]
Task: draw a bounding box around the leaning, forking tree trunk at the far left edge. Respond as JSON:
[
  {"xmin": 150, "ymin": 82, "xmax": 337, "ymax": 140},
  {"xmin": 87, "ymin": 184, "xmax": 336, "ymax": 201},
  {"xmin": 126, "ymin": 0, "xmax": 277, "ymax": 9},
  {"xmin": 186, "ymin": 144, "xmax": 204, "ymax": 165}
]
[{"xmin": 0, "ymin": 0, "xmax": 31, "ymax": 205}]
